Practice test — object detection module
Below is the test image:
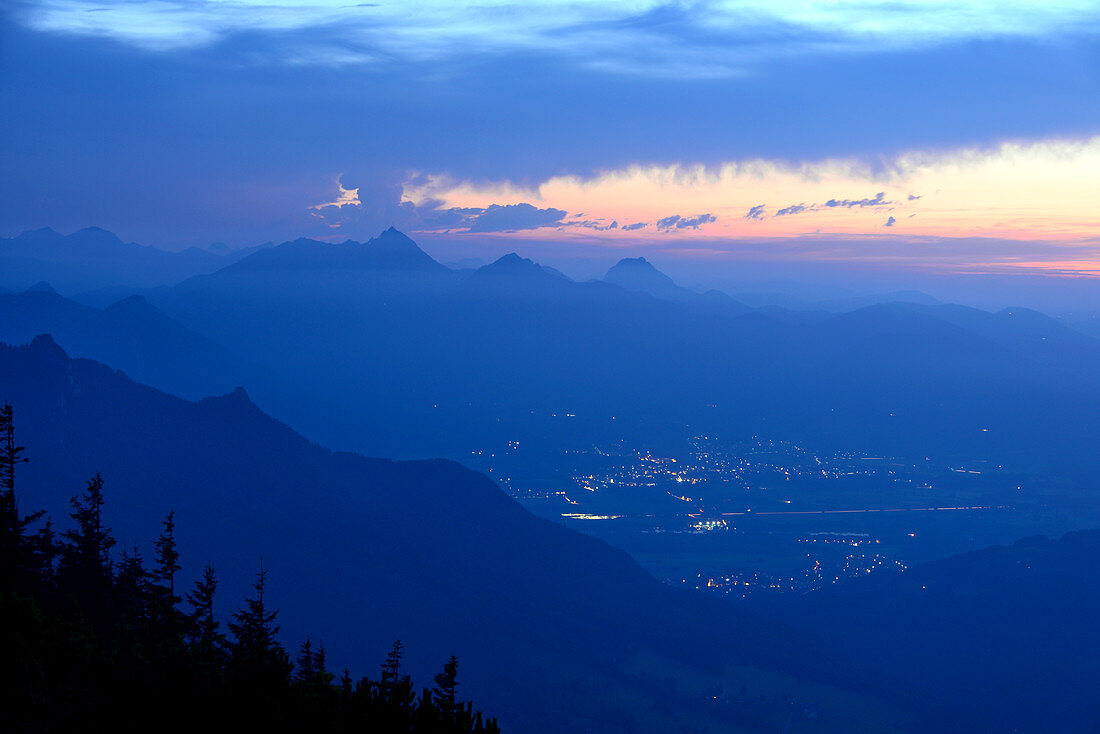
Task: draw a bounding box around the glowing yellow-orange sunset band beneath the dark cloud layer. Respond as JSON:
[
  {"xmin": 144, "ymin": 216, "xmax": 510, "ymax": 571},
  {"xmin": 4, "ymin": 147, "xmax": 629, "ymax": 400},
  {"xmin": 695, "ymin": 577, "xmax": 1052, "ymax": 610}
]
[{"xmin": 404, "ymin": 136, "xmax": 1100, "ymax": 242}]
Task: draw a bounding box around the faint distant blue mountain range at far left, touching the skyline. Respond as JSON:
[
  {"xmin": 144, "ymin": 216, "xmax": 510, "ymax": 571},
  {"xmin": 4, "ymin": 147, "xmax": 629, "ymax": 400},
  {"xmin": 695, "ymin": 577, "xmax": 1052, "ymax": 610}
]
[{"xmin": 0, "ymin": 227, "xmax": 264, "ymax": 293}]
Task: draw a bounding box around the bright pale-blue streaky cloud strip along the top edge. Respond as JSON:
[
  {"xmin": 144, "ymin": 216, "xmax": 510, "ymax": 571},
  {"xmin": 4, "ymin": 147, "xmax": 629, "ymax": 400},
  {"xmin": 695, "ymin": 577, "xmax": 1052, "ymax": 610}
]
[{"xmin": 17, "ymin": 0, "xmax": 1100, "ymax": 78}]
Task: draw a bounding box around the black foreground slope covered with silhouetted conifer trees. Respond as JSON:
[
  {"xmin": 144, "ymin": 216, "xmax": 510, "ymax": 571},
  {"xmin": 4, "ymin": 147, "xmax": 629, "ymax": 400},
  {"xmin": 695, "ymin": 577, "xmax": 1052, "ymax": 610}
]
[{"xmin": 0, "ymin": 405, "xmax": 501, "ymax": 734}]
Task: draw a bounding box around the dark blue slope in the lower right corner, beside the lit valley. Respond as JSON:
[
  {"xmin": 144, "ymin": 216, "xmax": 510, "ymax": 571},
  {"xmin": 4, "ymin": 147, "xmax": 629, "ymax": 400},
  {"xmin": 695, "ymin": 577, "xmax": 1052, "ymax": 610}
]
[{"xmin": 776, "ymin": 530, "xmax": 1100, "ymax": 732}]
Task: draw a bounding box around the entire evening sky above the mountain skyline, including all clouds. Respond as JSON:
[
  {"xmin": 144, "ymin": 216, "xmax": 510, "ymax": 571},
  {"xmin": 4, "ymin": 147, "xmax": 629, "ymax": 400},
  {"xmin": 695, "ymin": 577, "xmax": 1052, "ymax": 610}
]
[{"xmin": 0, "ymin": 0, "xmax": 1100, "ymax": 290}]
